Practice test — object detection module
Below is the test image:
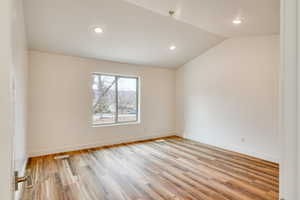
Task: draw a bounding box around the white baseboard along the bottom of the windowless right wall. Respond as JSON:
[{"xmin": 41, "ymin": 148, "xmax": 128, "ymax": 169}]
[{"xmin": 181, "ymin": 136, "xmax": 279, "ymax": 164}]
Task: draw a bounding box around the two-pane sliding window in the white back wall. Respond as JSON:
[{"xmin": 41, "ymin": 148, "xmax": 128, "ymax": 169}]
[{"xmin": 92, "ymin": 73, "xmax": 139, "ymax": 125}]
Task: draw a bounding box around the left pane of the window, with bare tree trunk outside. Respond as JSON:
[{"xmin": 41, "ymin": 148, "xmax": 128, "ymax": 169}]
[{"xmin": 92, "ymin": 75, "xmax": 116, "ymax": 124}]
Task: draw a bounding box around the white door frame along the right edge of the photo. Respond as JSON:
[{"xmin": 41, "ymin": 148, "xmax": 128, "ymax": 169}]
[{"xmin": 279, "ymin": 0, "xmax": 300, "ymax": 200}]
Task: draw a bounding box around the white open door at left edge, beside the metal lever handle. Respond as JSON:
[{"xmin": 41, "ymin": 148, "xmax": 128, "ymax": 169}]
[{"xmin": 0, "ymin": 0, "xmax": 14, "ymax": 200}]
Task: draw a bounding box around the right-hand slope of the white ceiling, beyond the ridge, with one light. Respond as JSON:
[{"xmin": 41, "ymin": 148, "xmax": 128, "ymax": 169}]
[{"xmin": 125, "ymin": 0, "xmax": 280, "ymax": 37}]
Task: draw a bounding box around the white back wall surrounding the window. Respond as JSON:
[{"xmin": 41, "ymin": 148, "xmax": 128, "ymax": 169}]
[{"xmin": 28, "ymin": 51, "xmax": 175, "ymax": 155}]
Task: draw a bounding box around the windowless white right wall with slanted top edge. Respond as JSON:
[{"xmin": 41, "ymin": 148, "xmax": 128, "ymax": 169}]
[{"xmin": 176, "ymin": 36, "xmax": 280, "ymax": 162}]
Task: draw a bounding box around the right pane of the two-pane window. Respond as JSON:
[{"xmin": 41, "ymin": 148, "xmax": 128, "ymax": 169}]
[{"xmin": 118, "ymin": 77, "xmax": 137, "ymax": 122}]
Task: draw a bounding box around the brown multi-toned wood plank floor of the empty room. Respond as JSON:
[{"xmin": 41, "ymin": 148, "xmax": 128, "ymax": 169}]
[{"xmin": 23, "ymin": 137, "xmax": 279, "ymax": 200}]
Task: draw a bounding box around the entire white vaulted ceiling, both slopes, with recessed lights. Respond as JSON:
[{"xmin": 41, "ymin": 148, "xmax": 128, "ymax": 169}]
[{"xmin": 24, "ymin": 0, "xmax": 279, "ymax": 68}]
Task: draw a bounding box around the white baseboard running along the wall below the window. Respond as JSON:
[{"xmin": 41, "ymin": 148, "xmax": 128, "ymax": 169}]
[{"xmin": 29, "ymin": 131, "xmax": 176, "ymax": 157}]
